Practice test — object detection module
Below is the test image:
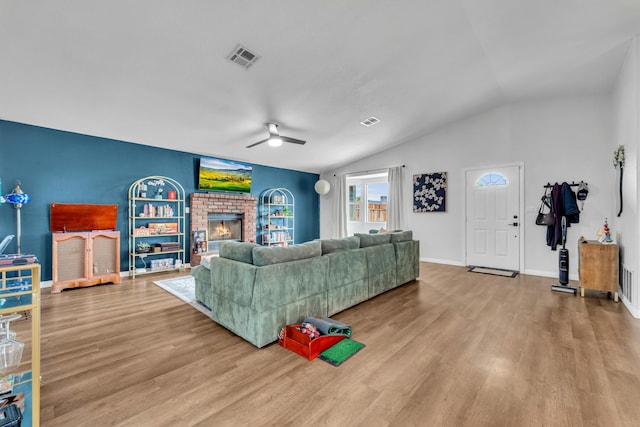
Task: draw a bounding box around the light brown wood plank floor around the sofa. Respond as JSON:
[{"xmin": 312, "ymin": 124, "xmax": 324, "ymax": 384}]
[{"xmin": 36, "ymin": 263, "xmax": 640, "ymax": 427}]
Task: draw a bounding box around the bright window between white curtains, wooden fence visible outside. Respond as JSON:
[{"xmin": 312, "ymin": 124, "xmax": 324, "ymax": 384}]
[{"xmin": 347, "ymin": 172, "xmax": 389, "ymax": 234}]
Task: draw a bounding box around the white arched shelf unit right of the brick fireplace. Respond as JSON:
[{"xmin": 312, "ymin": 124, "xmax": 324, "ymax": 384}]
[{"xmin": 259, "ymin": 188, "xmax": 295, "ymax": 246}]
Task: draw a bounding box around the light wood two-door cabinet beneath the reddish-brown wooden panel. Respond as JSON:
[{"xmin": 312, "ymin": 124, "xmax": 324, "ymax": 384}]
[{"xmin": 51, "ymin": 231, "xmax": 120, "ymax": 293}]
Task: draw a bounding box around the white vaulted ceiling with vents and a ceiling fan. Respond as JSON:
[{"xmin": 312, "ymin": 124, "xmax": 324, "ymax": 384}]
[{"xmin": 0, "ymin": 0, "xmax": 640, "ymax": 172}]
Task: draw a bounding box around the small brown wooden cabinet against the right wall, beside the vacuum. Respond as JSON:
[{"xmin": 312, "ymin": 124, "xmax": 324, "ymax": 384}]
[{"xmin": 578, "ymin": 239, "xmax": 619, "ymax": 302}]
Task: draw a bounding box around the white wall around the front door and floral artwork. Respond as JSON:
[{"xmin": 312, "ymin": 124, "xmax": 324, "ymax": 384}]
[{"xmin": 320, "ymin": 96, "xmax": 615, "ymax": 278}]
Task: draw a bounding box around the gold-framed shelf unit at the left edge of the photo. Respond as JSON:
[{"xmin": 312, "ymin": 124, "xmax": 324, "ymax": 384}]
[{"xmin": 0, "ymin": 264, "xmax": 40, "ymax": 427}]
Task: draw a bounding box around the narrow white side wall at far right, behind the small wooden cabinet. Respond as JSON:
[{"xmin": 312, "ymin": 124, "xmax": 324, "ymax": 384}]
[{"xmin": 609, "ymin": 37, "xmax": 640, "ymax": 317}]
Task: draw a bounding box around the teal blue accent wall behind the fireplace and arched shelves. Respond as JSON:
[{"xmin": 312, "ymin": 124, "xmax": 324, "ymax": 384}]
[{"xmin": 0, "ymin": 120, "xmax": 320, "ymax": 280}]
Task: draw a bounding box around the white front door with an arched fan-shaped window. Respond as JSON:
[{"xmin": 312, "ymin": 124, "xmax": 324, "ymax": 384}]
[{"xmin": 466, "ymin": 166, "xmax": 521, "ymax": 271}]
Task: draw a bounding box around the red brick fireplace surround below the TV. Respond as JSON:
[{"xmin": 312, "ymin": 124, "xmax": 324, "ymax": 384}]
[{"xmin": 189, "ymin": 193, "xmax": 258, "ymax": 266}]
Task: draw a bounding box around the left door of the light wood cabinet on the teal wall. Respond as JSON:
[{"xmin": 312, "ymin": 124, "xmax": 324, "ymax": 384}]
[{"xmin": 52, "ymin": 232, "xmax": 89, "ymax": 285}]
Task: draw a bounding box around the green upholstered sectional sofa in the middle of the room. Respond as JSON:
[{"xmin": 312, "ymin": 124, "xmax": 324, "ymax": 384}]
[{"xmin": 191, "ymin": 231, "xmax": 419, "ymax": 347}]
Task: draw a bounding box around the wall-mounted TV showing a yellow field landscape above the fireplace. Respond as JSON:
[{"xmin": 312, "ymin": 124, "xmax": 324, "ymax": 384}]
[{"xmin": 198, "ymin": 157, "xmax": 252, "ymax": 193}]
